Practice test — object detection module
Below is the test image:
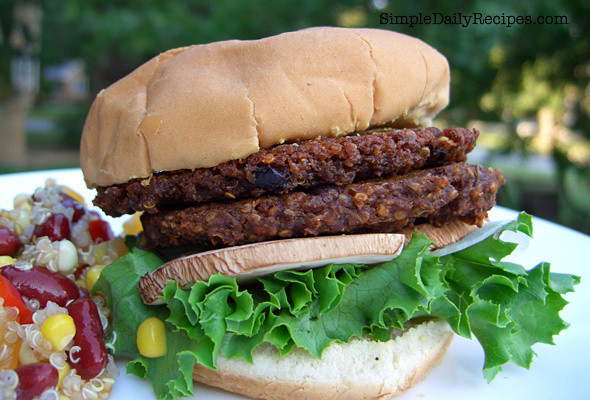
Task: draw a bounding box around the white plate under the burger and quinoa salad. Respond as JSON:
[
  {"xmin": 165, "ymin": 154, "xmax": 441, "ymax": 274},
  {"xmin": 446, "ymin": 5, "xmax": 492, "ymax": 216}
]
[{"xmin": 0, "ymin": 169, "xmax": 590, "ymax": 400}]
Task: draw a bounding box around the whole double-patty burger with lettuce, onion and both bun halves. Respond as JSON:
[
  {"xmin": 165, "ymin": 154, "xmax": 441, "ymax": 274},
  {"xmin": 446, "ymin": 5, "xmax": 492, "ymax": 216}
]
[{"xmin": 81, "ymin": 27, "xmax": 576, "ymax": 399}]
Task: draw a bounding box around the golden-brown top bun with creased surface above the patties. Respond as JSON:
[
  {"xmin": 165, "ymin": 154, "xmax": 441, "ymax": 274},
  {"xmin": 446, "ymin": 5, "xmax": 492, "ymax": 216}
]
[{"xmin": 80, "ymin": 27, "xmax": 449, "ymax": 187}]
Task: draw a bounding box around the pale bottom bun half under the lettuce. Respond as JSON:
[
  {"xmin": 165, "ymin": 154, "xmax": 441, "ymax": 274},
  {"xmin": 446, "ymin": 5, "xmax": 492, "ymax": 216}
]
[{"xmin": 193, "ymin": 319, "xmax": 453, "ymax": 400}]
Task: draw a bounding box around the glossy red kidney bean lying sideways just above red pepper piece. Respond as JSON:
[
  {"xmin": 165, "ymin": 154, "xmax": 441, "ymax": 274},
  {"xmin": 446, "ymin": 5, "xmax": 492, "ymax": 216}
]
[{"xmin": 0, "ymin": 265, "xmax": 80, "ymax": 307}]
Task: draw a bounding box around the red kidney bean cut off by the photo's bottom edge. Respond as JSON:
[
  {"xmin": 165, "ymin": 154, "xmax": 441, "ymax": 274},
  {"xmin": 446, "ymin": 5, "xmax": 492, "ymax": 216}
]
[{"xmin": 15, "ymin": 363, "xmax": 59, "ymax": 400}]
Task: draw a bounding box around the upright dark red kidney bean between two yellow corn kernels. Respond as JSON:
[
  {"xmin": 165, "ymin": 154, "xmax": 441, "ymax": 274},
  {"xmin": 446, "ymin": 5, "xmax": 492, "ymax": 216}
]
[{"xmin": 67, "ymin": 297, "xmax": 108, "ymax": 379}]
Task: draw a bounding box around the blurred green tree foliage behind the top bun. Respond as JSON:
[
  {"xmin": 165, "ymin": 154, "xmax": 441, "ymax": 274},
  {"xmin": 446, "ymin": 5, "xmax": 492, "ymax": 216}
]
[{"xmin": 0, "ymin": 0, "xmax": 590, "ymax": 230}]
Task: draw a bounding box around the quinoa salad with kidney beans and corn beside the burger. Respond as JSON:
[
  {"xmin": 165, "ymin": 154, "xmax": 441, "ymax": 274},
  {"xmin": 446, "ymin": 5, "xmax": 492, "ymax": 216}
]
[{"xmin": 0, "ymin": 179, "xmax": 127, "ymax": 400}]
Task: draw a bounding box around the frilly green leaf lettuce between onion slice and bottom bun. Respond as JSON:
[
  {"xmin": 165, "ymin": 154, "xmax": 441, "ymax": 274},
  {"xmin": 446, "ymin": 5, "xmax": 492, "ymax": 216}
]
[{"xmin": 93, "ymin": 213, "xmax": 579, "ymax": 399}]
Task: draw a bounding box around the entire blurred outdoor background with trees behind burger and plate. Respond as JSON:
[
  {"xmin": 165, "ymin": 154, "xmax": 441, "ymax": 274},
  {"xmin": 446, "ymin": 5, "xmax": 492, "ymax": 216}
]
[{"xmin": 0, "ymin": 0, "xmax": 590, "ymax": 232}]
